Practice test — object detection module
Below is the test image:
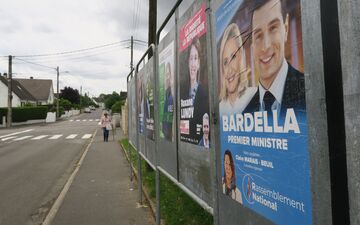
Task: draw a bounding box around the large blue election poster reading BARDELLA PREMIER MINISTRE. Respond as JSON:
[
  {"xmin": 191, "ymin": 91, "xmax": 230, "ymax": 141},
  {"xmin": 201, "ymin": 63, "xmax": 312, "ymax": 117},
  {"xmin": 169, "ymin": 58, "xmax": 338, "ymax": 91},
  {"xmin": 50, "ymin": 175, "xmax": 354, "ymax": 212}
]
[{"xmin": 215, "ymin": 0, "xmax": 312, "ymax": 225}]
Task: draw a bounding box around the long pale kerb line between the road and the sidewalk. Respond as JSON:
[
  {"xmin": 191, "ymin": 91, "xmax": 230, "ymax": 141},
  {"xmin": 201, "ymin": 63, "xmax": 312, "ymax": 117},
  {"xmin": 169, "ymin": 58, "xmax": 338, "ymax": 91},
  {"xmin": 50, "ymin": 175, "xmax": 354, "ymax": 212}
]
[{"xmin": 42, "ymin": 130, "xmax": 97, "ymax": 225}]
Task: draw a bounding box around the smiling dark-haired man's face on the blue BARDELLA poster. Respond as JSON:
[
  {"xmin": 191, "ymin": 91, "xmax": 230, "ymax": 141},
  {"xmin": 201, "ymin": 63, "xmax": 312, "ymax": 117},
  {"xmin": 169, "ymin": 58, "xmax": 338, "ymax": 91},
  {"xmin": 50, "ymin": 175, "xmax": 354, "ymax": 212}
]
[{"xmin": 252, "ymin": 0, "xmax": 288, "ymax": 85}]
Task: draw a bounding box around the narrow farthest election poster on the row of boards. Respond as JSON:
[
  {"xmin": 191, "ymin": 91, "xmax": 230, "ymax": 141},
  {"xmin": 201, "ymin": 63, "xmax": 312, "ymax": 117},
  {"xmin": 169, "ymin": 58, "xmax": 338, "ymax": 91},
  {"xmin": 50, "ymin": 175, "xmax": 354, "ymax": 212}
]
[{"xmin": 136, "ymin": 70, "xmax": 145, "ymax": 134}]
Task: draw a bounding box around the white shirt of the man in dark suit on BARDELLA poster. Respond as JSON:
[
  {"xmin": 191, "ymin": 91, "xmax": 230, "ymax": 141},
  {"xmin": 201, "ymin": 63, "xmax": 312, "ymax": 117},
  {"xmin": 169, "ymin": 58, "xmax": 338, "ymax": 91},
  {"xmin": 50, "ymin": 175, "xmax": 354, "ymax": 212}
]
[{"xmin": 259, "ymin": 59, "xmax": 289, "ymax": 115}]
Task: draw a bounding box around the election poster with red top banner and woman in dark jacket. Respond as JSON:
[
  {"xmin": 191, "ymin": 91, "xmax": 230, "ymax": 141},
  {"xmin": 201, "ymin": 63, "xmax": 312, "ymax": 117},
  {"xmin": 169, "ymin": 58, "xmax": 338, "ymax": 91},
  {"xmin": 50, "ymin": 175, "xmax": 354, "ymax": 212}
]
[{"xmin": 179, "ymin": 3, "xmax": 210, "ymax": 148}]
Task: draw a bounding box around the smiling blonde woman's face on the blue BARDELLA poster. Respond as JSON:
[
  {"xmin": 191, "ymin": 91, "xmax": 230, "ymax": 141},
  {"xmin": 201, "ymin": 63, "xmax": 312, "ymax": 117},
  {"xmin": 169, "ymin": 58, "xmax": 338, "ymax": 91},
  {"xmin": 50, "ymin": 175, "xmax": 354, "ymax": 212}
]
[{"xmin": 222, "ymin": 38, "xmax": 242, "ymax": 94}]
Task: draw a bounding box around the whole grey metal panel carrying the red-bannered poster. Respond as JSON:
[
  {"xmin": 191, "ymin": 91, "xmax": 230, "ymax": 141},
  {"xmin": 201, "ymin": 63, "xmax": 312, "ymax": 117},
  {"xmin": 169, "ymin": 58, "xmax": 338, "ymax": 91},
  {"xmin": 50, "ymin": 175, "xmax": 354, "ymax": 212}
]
[{"xmin": 177, "ymin": 1, "xmax": 213, "ymax": 206}]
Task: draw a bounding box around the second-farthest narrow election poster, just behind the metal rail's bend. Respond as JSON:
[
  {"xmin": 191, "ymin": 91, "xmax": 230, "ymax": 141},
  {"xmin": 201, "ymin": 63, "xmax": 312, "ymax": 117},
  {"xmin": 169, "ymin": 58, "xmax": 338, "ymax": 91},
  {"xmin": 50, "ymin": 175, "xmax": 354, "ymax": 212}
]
[{"xmin": 143, "ymin": 61, "xmax": 155, "ymax": 141}]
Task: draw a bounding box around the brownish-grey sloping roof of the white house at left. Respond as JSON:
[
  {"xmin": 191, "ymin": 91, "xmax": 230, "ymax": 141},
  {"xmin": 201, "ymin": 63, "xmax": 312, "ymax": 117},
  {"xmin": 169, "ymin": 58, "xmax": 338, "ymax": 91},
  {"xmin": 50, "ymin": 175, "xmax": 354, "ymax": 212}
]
[{"xmin": 14, "ymin": 78, "xmax": 52, "ymax": 101}]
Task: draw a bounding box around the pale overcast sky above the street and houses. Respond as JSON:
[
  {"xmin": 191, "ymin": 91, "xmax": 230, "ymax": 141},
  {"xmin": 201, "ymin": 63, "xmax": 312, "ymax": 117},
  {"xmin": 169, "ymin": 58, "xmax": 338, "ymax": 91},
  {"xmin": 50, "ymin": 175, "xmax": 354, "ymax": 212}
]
[{"xmin": 0, "ymin": 0, "xmax": 192, "ymax": 96}]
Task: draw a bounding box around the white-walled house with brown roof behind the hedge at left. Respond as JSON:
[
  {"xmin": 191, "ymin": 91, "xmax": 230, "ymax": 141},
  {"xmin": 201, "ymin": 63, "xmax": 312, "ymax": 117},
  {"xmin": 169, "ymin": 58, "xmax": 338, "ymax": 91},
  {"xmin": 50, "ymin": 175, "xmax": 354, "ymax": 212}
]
[{"xmin": 0, "ymin": 75, "xmax": 54, "ymax": 107}]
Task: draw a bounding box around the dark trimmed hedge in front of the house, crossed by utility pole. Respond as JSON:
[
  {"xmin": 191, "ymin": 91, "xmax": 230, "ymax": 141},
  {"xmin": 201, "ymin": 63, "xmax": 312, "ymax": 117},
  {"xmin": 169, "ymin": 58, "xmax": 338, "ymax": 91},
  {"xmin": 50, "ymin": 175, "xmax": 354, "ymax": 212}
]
[{"xmin": 0, "ymin": 106, "xmax": 48, "ymax": 123}]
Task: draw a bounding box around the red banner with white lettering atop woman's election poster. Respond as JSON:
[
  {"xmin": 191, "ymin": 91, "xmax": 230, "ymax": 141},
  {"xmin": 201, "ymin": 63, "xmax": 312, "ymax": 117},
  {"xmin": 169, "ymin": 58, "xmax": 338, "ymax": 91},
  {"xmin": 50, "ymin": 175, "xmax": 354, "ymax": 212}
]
[{"xmin": 179, "ymin": 3, "xmax": 206, "ymax": 52}]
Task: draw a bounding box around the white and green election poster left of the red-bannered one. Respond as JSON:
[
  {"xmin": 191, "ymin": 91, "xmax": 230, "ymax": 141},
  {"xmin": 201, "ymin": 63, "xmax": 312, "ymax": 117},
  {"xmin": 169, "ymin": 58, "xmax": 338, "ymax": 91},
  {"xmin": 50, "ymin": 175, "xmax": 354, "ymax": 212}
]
[{"xmin": 159, "ymin": 41, "xmax": 176, "ymax": 142}]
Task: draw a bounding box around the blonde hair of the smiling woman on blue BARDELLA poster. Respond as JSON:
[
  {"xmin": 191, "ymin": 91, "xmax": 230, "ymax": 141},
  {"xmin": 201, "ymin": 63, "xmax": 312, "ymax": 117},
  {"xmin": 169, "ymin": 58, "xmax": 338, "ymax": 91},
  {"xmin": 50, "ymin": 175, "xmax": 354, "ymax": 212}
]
[{"xmin": 219, "ymin": 23, "xmax": 250, "ymax": 100}]
